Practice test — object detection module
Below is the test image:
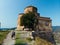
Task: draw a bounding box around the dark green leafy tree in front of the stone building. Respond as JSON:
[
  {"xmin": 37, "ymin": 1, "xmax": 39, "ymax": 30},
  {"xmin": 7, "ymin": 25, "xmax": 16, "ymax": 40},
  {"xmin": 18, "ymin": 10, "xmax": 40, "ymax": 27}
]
[{"xmin": 21, "ymin": 12, "xmax": 36, "ymax": 29}]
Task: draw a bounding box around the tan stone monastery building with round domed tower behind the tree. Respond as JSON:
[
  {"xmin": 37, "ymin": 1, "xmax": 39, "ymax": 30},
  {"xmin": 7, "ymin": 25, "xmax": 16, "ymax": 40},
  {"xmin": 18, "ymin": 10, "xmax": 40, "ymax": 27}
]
[{"xmin": 17, "ymin": 6, "xmax": 52, "ymax": 31}]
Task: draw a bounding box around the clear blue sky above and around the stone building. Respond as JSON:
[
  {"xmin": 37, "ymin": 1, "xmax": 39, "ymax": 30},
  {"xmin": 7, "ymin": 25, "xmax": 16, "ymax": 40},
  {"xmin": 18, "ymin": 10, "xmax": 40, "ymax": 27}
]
[{"xmin": 0, "ymin": 0, "xmax": 60, "ymax": 28}]
